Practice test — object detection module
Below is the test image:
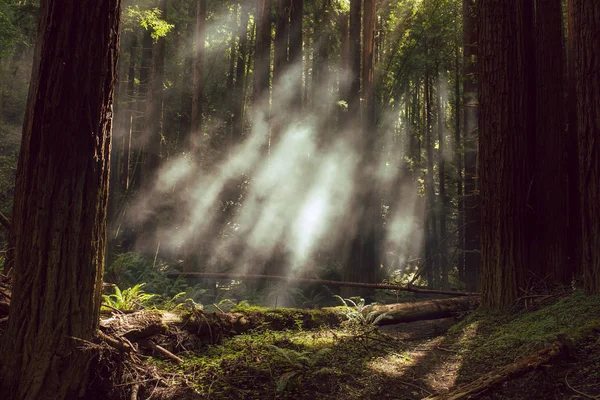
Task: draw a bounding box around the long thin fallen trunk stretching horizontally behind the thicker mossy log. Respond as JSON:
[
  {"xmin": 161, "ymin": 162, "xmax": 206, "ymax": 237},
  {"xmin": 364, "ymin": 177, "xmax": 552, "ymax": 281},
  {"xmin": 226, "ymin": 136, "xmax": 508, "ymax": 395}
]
[{"xmin": 168, "ymin": 272, "xmax": 479, "ymax": 296}]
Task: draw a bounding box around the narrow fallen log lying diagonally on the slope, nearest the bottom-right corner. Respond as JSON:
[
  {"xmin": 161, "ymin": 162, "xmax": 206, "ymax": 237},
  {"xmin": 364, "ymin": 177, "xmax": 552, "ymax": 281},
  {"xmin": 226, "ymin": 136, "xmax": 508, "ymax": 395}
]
[{"xmin": 424, "ymin": 342, "xmax": 567, "ymax": 400}]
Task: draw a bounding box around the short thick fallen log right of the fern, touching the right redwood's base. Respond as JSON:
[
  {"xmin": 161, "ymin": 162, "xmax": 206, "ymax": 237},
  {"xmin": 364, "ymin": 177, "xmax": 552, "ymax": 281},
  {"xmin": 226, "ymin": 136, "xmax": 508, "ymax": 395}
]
[{"xmin": 369, "ymin": 296, "xmax": 480, "ymax": 325}]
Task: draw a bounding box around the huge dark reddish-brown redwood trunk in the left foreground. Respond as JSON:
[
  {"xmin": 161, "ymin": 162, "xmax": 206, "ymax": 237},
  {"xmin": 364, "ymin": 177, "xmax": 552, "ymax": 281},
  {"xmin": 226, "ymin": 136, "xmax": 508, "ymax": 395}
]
[{"xmin": 0, "ymin": 0, "xmax": 121, "ymax": 400}]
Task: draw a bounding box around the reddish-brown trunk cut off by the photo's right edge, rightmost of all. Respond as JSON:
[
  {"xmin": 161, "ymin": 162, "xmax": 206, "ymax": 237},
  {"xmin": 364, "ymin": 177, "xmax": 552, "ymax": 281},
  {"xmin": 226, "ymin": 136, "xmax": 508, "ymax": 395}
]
[{"xmin": 572, "ymin": 0, "xmax": 600, "ymax": 294}]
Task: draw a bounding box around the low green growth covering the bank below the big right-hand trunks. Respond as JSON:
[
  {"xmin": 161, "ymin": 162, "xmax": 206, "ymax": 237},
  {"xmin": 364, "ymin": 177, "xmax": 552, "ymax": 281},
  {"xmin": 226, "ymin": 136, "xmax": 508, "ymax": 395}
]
[{"xmin": 450, "ymin": 291, "xmax": 600, "ymax": 367}]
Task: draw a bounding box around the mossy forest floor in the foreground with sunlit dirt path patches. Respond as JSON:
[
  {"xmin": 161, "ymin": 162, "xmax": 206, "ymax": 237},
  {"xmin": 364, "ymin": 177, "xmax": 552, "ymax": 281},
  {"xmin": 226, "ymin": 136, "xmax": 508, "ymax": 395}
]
[{"xmin": 85, "ymin": 292, "xmax": 600, "ymax": 400}]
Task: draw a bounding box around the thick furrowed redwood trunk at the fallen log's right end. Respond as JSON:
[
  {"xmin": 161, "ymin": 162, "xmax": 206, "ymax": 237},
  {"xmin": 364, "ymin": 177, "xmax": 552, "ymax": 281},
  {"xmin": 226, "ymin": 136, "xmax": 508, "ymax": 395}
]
[{"xmin": 479, "ymin": 1, "xmax": 533, "ymax": 308}]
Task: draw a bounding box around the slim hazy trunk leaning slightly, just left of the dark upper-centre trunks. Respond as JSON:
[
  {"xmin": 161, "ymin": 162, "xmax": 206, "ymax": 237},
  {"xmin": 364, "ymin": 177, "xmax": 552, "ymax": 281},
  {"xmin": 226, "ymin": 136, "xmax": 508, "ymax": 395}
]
[{"xmin": 232, "ymin": 3, "xmax": 250, "ymax": 143}]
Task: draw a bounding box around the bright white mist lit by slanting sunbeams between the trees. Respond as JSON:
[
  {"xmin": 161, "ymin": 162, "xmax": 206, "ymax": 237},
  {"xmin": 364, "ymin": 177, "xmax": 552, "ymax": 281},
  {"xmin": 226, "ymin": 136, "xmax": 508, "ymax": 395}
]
[{"xmin": 126, "ymin": 61, "xmax": 423, "ymax": 272}]
